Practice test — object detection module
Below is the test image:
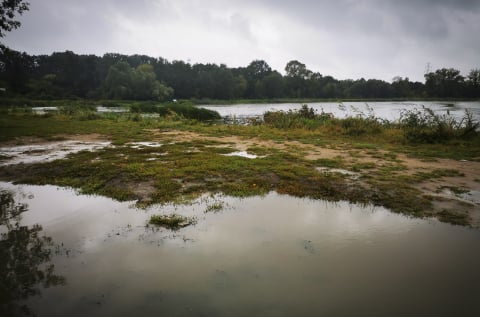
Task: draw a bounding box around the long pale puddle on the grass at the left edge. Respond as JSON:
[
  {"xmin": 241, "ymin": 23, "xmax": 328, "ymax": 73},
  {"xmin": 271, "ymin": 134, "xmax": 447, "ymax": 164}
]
[{"xmin": 0, "ymin": 141, "xmax": 111, "ymax": 165}]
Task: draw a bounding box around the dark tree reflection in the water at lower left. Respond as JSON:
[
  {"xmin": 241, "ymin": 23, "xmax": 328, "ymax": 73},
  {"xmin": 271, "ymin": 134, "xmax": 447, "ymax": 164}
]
[{"xmin": 0, "ymin": 190, "xmax": 65, "ymax": 316}]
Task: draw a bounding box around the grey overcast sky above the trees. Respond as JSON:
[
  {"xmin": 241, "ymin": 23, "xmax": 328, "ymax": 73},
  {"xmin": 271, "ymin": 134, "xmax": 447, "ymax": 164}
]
[{"xmin": 3, "ymin": 0, "xmax": 480, "ymax": 82}]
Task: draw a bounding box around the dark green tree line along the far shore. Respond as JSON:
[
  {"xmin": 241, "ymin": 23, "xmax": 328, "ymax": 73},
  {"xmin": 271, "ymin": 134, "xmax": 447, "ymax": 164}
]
[{"xmin": 0, "ymin": 46, "xmax": 480, "ymax": 101}]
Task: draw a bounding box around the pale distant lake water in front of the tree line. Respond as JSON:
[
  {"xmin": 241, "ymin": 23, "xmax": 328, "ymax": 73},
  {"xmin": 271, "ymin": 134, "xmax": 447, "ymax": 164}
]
[{"xmin": 201, "ymin": 101, "xmax": 480, "ymax": 121}]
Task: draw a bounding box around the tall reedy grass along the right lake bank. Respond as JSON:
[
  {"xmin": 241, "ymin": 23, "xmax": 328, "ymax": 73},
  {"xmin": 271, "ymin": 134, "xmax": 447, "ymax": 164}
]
[{"xmin": 264, "ymin": 105, "xmax": 480, "ymax": 143}]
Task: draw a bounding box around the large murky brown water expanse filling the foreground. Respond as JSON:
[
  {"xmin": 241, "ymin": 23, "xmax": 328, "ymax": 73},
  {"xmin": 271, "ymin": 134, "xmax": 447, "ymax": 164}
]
[{"xmin": 0, "ymin": 183, "xmax": 480, "ymax": 317}]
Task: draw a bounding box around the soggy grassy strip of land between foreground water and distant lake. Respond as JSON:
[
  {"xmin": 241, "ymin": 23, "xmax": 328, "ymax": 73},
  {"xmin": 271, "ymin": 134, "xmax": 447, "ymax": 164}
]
[{"xmin": 0, "ymin": 102, "xmax": 480, "ymax": 227}]
